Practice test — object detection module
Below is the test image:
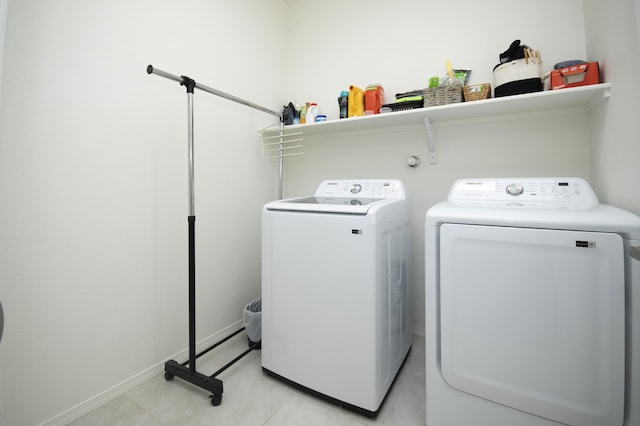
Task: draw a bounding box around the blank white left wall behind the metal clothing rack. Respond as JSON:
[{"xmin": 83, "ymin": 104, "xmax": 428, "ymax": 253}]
[{"xmin": 0, "ymin": 0, "xmax": 285, "ymax": 425}]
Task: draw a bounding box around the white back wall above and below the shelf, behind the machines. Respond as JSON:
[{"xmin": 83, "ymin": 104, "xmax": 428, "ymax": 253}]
[{"xmin": 286, "ymin": 0, "xmax": 591, "ymax": 333}]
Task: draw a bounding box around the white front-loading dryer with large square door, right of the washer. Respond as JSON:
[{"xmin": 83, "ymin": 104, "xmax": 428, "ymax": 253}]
[{"xmin": 425, "ymin": 178, "xmax": 640, "ymax": 426}]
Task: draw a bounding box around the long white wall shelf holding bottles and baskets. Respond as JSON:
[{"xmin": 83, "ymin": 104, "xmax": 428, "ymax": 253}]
[{"xmin": 262, "ymin": 83, "xmax": 611, "ymax": 139}]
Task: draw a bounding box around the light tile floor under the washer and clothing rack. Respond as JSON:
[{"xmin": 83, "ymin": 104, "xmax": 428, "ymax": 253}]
[{"xmin": 71, "ymin": 333, "xmax": 425, "ymax": 426}]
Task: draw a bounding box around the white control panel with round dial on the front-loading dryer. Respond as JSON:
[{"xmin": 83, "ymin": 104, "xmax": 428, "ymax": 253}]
[{"xmin": 448, "ymin": 177, "xmax": 598, "ymax": 209}]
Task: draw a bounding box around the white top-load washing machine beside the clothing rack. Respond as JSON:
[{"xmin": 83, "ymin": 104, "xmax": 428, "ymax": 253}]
[{"xmin": 262, "ymin": 179, "xmax": 411, "ymax": 415}]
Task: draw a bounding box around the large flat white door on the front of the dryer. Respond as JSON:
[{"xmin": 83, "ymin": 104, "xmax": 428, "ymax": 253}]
[{"xmin": 439, "ymin": 224, "xmax": 625, "ymax": 426}]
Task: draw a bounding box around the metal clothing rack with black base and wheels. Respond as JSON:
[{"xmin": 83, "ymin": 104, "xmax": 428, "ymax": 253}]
[{"xmin": 147, "ymin": 65, "xmax": 284, "ymax": 406}]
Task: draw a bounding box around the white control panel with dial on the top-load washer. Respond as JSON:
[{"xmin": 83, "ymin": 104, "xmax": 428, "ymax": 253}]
[{"xmin": 314, "ymin": 179, "xmax": 405, "ymax": 199}]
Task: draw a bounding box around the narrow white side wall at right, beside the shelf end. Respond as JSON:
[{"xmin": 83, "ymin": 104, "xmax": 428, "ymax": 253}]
[{"xmin": 585, "ymin": 0, "xmax": 640, "ymax": 214}]
